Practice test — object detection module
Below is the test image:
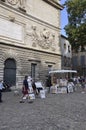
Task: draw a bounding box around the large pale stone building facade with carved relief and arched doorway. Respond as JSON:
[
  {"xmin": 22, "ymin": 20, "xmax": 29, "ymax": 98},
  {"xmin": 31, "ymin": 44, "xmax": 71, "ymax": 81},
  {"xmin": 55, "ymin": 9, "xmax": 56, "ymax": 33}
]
[{"xmin": 0, "ymin": 0, "xmax": 63, "ymax": 87}]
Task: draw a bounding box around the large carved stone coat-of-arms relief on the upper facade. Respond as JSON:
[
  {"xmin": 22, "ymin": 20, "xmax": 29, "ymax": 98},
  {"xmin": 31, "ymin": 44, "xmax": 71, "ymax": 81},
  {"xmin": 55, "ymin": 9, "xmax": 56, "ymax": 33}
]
[{"xmin": 26, "ymin": 26, "xmax": 55, "ymax": 51}]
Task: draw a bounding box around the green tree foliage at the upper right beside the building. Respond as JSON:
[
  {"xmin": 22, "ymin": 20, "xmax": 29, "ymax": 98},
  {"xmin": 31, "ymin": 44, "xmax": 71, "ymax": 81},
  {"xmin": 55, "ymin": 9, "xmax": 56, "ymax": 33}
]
[{"xmin": 64, "ymin": 0, "xmax": 86, "ymax": 51}]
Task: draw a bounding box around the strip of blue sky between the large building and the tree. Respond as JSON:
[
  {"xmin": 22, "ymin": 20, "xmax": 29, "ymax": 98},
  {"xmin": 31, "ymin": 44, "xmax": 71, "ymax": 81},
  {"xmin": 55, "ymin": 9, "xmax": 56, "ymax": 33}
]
[{"xmin": 61, "ymin": 0, "xmax": 68, "ymax": 36}]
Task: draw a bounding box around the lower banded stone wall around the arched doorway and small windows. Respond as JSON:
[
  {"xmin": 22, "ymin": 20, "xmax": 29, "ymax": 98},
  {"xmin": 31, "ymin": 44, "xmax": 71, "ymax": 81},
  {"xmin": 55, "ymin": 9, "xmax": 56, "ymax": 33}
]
[{"xmin": 0, "ymin": 45, "xmax": 61, "ymax": 86}]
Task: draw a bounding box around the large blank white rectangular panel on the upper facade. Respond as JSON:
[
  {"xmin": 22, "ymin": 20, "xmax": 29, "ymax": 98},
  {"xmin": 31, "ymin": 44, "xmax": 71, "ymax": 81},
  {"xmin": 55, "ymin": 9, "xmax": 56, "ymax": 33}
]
[{"xmin": 0, "ymin": 18, "xmax": 24, "ymax": 41}]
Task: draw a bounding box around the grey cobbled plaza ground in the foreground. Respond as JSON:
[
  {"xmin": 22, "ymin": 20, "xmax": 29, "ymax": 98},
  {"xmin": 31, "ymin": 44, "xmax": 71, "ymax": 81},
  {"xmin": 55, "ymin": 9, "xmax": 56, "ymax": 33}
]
[{"xmin": 0, "ymin": 87, "xmax": 86, "ymax": 130}]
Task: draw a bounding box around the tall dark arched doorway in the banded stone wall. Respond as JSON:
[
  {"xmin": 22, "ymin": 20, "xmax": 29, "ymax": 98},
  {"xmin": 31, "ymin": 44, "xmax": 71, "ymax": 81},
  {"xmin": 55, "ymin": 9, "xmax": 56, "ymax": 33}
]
[{"xmin": 4, "ymin": 58, "xmax": 16, "ymax": 86}]
